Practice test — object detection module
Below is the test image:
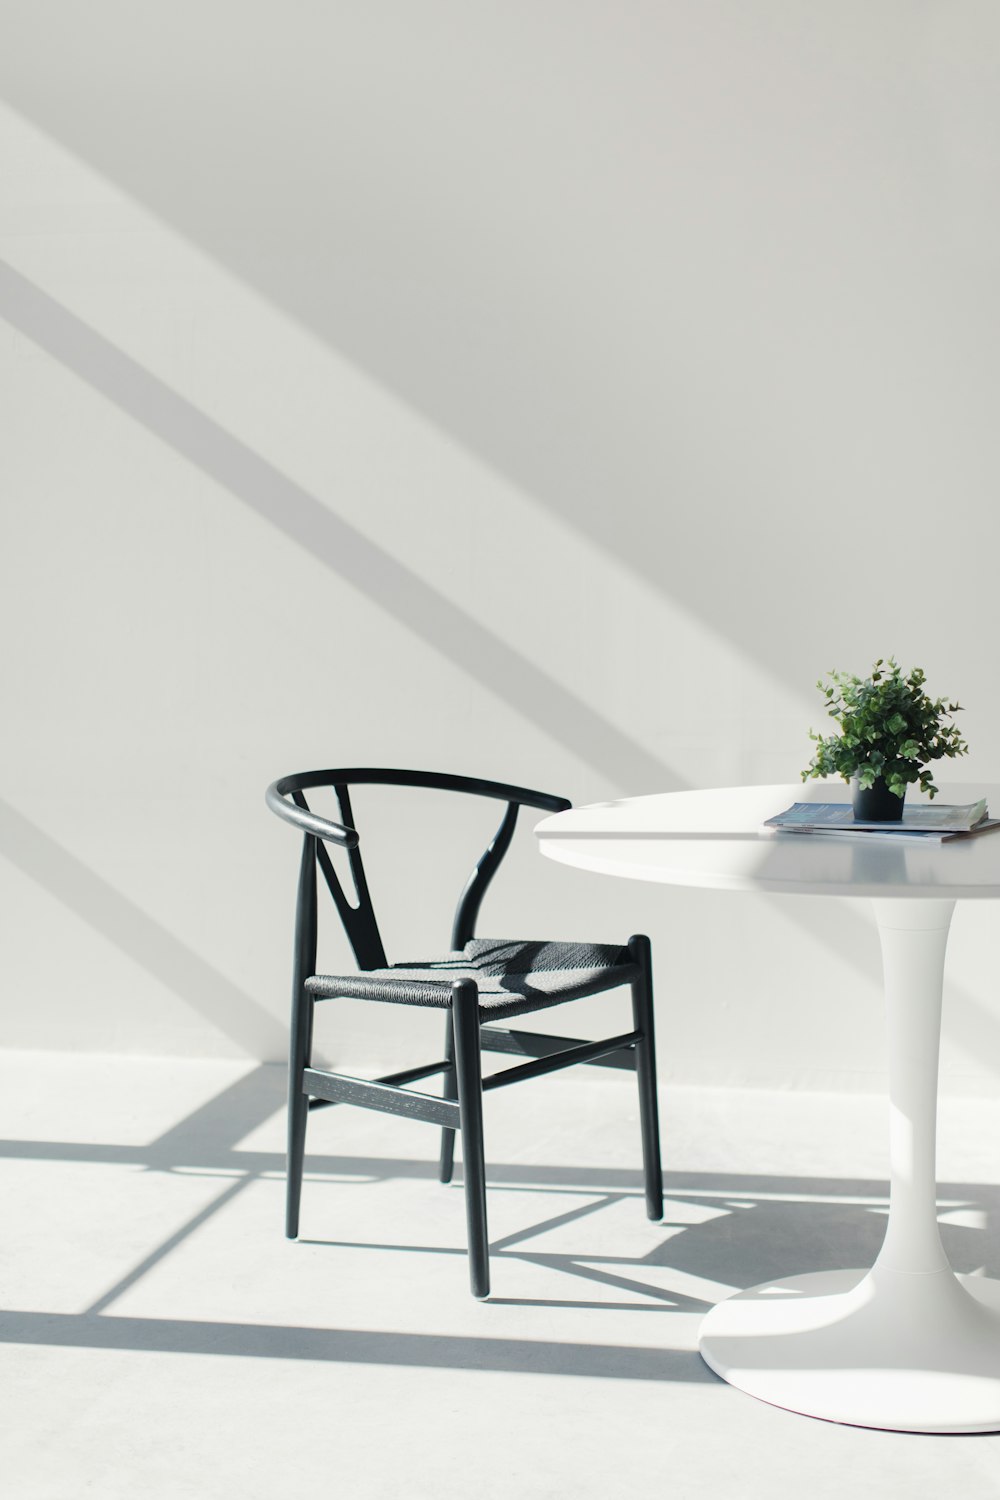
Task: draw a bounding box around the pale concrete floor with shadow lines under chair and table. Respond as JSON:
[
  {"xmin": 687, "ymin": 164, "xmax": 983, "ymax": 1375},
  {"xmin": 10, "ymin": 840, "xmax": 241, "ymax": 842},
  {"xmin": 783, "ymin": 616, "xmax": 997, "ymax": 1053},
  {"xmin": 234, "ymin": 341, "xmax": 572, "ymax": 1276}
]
[{"xmin": 0, "ymin": 1053, "xmax": 1000, "ymax": 1500}]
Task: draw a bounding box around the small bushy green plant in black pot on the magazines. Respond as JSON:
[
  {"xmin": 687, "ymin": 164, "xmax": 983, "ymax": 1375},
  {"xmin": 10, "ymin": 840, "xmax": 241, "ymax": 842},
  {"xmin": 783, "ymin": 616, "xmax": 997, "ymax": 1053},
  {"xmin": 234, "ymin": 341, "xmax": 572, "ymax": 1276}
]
[{"xmin": 802, "ymin": 657, "xmax": 969, "ymax": 822}]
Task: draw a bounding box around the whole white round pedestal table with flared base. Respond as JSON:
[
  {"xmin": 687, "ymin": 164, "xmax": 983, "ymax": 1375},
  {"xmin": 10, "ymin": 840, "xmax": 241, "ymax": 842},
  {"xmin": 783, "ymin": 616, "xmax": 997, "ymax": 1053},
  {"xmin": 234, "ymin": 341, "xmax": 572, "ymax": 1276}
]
[{"xmin": 535, "ymin": 783, "xmax": 1000, "ymax": 1433}]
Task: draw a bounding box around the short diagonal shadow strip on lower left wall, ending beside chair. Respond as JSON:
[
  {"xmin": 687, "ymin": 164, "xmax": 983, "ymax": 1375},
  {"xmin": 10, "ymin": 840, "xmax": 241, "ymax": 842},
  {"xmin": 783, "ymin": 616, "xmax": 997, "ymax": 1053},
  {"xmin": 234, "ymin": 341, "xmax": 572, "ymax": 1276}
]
[{"xmin": 0, "ymin": 800, "xmax": 285, "ymax": 1058}]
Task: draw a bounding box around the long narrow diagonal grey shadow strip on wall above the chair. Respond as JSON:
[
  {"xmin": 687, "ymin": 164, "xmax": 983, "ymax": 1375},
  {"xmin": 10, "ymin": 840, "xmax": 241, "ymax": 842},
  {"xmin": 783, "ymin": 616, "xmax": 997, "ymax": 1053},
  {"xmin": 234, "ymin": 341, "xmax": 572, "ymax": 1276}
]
[{"xmin": 0, "ymin": 261, "xmax": 678, "ymax": 789}]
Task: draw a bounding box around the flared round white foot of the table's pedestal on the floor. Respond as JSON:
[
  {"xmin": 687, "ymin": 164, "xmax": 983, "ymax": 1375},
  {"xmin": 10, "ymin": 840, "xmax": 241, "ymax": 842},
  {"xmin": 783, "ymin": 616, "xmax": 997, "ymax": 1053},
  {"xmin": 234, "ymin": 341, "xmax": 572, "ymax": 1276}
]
[{"xmin": 700, "ymin": 1266, "xmax": 1000, "ymax": 1433}]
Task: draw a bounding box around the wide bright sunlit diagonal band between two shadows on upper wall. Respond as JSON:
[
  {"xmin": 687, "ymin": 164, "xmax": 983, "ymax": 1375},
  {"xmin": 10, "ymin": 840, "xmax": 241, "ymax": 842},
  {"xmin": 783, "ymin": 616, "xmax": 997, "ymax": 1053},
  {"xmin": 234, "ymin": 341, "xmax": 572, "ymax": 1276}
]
[{"xmin": 0, "ymin": 101, "xmax": 807, "ymax": 795}]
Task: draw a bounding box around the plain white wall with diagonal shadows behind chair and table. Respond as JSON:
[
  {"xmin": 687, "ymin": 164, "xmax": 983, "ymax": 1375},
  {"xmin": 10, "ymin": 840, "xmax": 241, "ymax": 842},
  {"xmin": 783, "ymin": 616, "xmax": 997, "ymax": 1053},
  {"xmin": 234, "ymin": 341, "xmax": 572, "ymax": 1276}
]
[{"xmin": 0, "ymin": 0, "xmax": 1000, "ymax": 1091}]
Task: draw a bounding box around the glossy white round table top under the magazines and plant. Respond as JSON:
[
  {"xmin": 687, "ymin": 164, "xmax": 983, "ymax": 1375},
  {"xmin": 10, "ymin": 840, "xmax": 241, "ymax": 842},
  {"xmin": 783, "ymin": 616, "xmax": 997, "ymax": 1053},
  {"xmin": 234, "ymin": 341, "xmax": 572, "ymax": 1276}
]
[{"xmin": 535, "ymin": 782, "xmax": 1000, "ymax": 900}]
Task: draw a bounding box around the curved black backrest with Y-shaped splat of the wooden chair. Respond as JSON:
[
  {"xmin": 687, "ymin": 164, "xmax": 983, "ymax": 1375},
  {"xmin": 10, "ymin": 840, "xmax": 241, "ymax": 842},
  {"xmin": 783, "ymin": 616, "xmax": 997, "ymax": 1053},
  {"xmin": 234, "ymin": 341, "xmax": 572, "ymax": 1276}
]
[{"xmin": 267, "ymin": 767, "xmax": 573, "ymax": 969}]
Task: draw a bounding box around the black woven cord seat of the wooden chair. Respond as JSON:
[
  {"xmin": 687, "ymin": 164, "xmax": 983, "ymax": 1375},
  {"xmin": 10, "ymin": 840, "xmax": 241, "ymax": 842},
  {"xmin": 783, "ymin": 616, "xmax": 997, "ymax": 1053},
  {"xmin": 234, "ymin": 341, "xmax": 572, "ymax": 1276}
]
[{"xmin": 306, "ymin": 938, "xmax": 637, "ymax": 1020}]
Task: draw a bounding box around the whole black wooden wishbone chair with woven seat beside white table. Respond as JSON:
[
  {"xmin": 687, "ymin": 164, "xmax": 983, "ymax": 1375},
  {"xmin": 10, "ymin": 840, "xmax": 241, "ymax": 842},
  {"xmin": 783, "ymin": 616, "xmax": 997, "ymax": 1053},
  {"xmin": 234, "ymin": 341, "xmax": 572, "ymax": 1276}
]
[{"xmin": 267, "ymin": 770, "xmax": 663, "ymax": 1298}]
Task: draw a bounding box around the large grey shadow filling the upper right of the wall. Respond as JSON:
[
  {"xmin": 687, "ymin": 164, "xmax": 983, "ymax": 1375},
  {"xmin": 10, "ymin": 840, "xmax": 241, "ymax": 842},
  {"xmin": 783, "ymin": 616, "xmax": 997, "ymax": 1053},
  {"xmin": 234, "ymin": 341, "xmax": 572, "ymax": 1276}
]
[{"xmin": 0, "ymin": 0, "xmax": 996, "ymax": 677}]
